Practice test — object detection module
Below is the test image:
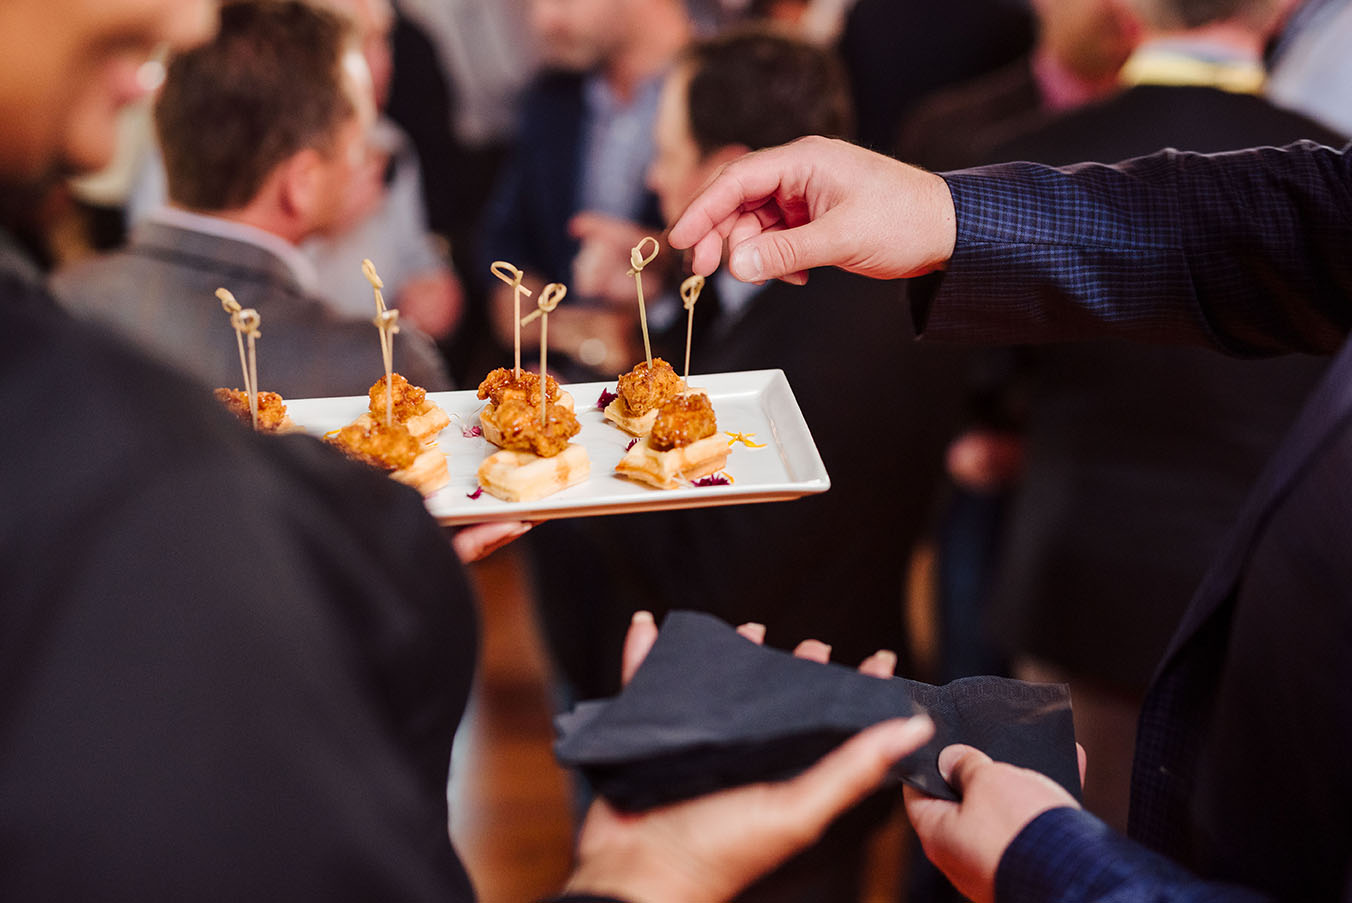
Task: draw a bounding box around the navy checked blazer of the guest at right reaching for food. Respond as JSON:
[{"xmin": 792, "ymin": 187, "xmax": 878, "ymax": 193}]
[{"xmin": 915, "ymin": 145, "xmax": 1352, "ymax": 900}]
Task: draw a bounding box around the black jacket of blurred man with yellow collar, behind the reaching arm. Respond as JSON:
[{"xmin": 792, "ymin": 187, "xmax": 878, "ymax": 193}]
[{"xmin": 987, "ymin": 85, "xmax": 1341, "ymax": 693}]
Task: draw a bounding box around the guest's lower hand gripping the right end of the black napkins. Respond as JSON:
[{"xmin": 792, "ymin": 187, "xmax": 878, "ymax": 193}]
[{"xmin": 904, "ymin": 745, "xmax": 1084, "ymax": 903}]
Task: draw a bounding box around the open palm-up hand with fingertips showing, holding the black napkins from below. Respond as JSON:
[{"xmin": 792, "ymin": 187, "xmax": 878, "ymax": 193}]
[{"xmin": 568, "ymin": 612, "xmax": 934, "ymax": 903}]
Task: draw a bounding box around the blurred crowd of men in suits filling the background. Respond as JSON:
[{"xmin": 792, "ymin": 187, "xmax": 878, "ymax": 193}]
[{"xmin": 27, "ymin": 0, "xmax": 1352, "ymax": 903}]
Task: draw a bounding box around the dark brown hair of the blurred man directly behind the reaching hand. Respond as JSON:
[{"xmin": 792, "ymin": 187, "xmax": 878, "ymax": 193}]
[{"xmin": 684, "ymin": 27, "xmax": 853, "ymax": 155}]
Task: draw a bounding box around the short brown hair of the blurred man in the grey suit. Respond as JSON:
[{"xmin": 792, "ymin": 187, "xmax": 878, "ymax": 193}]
[{"xmin": 155, "ymin": 0, "xmax": 354, "ymax": 211}]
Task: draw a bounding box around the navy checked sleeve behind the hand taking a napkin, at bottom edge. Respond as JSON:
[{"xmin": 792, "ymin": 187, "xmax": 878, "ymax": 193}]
[{"xmin": 995, "ymin": 807, "xmax": 1268, "ymax": 903}]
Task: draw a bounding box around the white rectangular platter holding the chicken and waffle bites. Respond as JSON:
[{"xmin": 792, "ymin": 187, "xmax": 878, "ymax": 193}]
[{"xmin": 287, "ymin": 370, "xmax": 830, "ymax": 524}]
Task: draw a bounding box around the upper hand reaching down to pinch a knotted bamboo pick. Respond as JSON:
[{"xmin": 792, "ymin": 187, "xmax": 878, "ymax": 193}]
[{"xmin": 668, "ymin": 138, "xmax": 956, "ymax": 283}]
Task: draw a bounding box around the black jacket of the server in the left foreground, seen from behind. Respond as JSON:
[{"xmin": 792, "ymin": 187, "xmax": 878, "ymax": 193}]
[{"xmin": 0, "ymin": 237, "xmax": 476, "ymax": 903}]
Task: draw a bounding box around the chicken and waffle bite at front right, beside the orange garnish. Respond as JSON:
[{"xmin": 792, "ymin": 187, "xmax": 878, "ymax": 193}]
[{"xmin": 615, "ymin": 393, "xmax": 729, "ymax": 489}]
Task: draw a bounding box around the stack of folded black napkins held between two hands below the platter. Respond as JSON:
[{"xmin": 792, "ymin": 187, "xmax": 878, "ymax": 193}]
[{"xmin": 554, "ymin": 611, "xmax": 1080, "ymax": 811}]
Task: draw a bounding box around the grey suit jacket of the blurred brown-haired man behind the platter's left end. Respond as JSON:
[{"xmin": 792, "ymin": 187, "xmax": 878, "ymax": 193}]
[{"xmin": 53, "ymin": 222, "xmax": 450, "ymax": 399}]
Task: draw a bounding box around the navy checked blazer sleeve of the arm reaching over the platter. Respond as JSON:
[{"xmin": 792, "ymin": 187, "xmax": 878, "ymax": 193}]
[{"xmin": 913, "ymin": 142, "xmax": 1352, "ymax": 356}]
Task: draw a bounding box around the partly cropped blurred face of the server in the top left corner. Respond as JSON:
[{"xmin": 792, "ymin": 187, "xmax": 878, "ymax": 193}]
[{"xmin": 0, "ymin": 0, "xmax": 216, "ymax": 182}]
